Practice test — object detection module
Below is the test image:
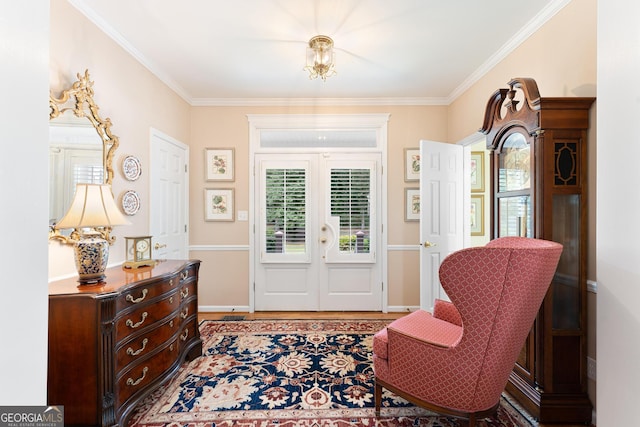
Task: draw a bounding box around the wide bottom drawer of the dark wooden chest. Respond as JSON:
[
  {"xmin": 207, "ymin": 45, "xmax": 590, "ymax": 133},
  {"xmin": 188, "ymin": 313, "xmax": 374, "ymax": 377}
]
[{"xmin": 116, "ymin": 341, "xmax": 180, "ymax": 407}]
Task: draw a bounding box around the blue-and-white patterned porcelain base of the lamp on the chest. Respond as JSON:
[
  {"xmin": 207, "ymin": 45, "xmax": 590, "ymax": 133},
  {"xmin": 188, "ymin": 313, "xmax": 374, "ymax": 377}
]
[{"xmin": 75, "ymin": 235, "xmax": 109, "ymax": 285}]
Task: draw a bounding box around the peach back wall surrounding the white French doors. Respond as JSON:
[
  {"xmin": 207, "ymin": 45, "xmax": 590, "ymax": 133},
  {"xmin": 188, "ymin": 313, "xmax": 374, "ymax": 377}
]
[{"xmin": 190, "ymin": 106, "xmax": 447, "ymax": 308}]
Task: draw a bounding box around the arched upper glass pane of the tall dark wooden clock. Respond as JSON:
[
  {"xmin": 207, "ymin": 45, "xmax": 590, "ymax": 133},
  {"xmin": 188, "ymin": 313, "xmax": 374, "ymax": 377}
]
[{"xmin": 498, "ymin": 133, "xmax": 531, "ymax": 192}]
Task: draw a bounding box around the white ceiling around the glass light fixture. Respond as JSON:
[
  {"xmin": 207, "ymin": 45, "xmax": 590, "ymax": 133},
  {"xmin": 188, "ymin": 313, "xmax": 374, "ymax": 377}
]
[{"xmin": 69, "ymin": 0, "xmax": 571, "ymax": 105}]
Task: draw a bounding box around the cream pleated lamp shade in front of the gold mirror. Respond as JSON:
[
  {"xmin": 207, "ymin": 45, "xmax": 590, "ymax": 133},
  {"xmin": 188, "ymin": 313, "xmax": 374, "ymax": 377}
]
[{"xmin": 55, "ymin": 184, "xmax": 131, "ymax": 229}]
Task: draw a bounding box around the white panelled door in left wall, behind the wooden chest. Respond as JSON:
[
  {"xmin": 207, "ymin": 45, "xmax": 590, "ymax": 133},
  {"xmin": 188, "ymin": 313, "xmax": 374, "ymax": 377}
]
[{"xmin": 150, "ymin": 130, "xmax": 189, "ymax": 259}]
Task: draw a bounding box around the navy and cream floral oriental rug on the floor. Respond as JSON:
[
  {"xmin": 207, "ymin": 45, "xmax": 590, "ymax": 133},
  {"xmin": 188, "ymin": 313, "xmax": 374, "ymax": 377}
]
[{"xmin": 129, "ymin": 320, "xmax": 537, "ymax": 427}]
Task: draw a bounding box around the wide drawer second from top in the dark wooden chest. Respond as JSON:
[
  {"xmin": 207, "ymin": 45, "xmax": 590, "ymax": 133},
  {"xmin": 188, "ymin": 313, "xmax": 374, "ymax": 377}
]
[{"xmin": 116, "ymin": 292, "xmax": 180, "ymax": 345}]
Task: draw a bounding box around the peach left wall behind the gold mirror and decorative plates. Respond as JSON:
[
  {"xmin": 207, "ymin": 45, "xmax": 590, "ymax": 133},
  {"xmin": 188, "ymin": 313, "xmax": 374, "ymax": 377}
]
[{"xmin": 48, "ymin": 1, "xmax": 191, "ymax": 279}]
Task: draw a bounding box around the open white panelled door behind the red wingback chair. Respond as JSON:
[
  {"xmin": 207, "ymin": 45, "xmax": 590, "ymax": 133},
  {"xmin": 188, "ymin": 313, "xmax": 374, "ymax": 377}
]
[{"xmin": 420, "ymin": 141, "xmax": 468, "ymax": 311}]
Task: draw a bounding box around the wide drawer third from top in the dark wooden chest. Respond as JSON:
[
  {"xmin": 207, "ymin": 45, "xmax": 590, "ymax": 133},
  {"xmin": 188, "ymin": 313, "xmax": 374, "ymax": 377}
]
[{"xmin": 116, "ymin": 315, "xmax": 182, "ymax": 372}]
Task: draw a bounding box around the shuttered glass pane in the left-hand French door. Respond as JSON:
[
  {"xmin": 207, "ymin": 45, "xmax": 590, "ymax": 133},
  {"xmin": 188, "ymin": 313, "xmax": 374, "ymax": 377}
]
[{"xmin": 265, "ymin": 169, "xmax": 307, "ymax": 254}]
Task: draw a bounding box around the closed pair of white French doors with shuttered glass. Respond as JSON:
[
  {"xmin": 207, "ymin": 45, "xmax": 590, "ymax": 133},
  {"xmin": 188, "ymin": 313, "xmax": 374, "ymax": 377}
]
[{"xmin": 254, "ymin": 153, "xmax": 382, "ymax": 311}]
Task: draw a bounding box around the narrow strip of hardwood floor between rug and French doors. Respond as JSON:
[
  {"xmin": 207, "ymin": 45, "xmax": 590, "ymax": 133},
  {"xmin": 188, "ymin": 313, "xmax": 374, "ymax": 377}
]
[{"xmin": 198, "ymin": 311, "xmax": 595, "ymax": 427}]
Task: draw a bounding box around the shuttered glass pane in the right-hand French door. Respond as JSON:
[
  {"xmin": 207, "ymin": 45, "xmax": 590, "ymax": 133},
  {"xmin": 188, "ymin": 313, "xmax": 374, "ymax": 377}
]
[{"xmin": 331, "ymin": 169, "xmax": 371, "ymax": 253}]
